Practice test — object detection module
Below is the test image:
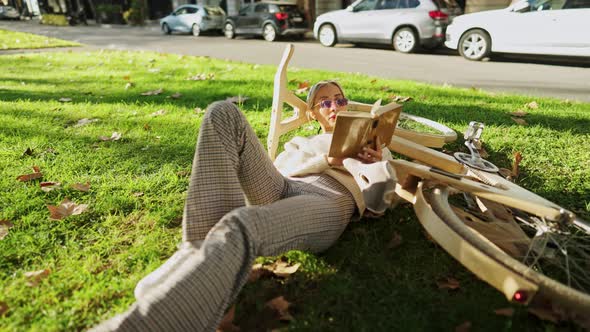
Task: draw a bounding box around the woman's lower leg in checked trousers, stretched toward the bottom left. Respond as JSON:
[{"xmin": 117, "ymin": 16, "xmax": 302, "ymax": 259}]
[{"xmin": 95, "ymin": 177, "xmax": 355, "ymax": 331}]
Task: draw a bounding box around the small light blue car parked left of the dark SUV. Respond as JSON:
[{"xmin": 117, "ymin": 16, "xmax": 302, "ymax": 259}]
[{"xmin": 160, "ymin": 5, "xmax": 225, "ymax": 36}]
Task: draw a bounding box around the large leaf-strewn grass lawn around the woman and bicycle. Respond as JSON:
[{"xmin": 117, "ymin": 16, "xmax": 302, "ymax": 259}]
[{"xmin": 0, "ymin": 47, "xmax": 590, "ymax": 331}]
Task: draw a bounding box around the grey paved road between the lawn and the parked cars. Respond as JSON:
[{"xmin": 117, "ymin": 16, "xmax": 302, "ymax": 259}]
[{"xmin": 0, "ymin": 22, "xmax": 590, "ymax": 101}]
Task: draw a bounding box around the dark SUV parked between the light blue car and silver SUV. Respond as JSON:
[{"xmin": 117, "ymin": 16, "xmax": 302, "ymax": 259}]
[{"xmin": 224, "ymin": 1, "xmax": 310, "ymax": 42}]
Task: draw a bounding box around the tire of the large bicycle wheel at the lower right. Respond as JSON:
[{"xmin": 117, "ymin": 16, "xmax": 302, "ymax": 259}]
[{"xmin": 426, "ymin": 185, "xmax": 590, "ymax": 315}]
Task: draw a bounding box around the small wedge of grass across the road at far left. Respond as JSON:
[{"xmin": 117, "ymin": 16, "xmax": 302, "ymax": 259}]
[{"xmin": 0, "ymin": 29, "xmax": 81, "ymax": 50}]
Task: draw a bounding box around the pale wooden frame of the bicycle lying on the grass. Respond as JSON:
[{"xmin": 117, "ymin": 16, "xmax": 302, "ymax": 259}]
[{"xmin": 267, "ymin": 45, "xmax": 580, "ymax": 303}]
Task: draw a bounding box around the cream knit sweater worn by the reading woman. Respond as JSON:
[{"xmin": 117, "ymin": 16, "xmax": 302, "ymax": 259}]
[{"xmin": 274, "ymin": 134, "xmax": 393, "ymax": 215}]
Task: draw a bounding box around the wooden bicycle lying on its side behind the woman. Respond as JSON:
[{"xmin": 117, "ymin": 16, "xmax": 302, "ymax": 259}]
[{"xmin": 267, "ymin": 45, "xmax": 590, "ymax": 317}]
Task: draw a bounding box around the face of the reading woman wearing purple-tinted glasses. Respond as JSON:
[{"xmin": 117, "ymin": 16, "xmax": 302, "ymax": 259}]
[{"xmin": 312, "ymin": 84, "xmax": 346, "ymax": 132}]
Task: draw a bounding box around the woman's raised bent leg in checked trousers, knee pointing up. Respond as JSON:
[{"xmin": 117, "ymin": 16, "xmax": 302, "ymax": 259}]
[{"xmin": 182, "ymin": 102, "xmax": 286, "ymax": 241}]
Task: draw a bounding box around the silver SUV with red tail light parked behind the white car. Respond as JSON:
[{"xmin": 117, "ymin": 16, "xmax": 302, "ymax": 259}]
[{"xmin": 313, "ymin": 0, "xmax": 461, "ymax": 53}]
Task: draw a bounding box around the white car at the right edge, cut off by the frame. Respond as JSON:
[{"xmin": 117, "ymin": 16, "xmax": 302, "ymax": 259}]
[{"xmin": 445, "ymin": 0, "xmax": 590, "ymax": 60}]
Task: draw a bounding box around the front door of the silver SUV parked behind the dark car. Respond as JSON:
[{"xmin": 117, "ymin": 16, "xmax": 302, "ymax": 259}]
[{"xmin": 338, "ymin": 0, "xmax": 378, "ymax": 42}]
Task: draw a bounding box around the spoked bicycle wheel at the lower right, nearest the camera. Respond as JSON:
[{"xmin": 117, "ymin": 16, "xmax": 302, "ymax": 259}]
[{"xmin": 425, "ymin": 184, "xmax": 590, "ymax": 318}]
